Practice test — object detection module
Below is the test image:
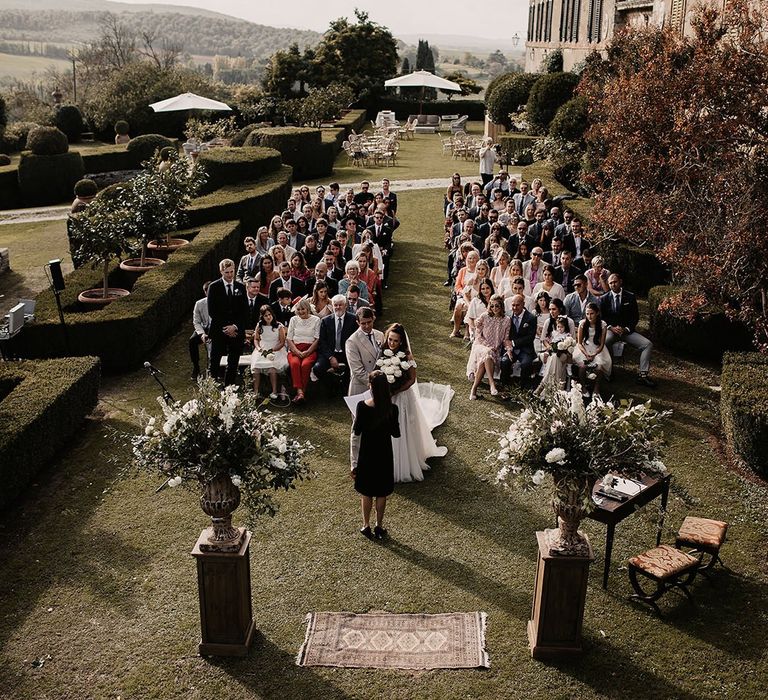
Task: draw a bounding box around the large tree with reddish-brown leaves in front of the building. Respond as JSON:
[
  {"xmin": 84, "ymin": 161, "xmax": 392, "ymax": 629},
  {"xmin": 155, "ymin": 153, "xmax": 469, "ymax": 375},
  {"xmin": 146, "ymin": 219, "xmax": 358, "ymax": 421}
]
[{"xmin": 579, "ymin": 0, "xmax": 768, "ymax": 352}]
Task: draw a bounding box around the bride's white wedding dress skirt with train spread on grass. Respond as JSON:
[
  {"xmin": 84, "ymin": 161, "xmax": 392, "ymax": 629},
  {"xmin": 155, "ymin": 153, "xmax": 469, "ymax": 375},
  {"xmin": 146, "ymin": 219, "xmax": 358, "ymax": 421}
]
[{"xmin": 392, "ymin": 382, "xmax": 454, "ymax": 483}]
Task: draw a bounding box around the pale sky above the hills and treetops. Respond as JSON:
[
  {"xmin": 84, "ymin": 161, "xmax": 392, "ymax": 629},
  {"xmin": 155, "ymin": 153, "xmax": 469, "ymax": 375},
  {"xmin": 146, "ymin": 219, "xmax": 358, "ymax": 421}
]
[{"xmin": 120, "ymin": 0, "xmax": 528, "ymax": 44}]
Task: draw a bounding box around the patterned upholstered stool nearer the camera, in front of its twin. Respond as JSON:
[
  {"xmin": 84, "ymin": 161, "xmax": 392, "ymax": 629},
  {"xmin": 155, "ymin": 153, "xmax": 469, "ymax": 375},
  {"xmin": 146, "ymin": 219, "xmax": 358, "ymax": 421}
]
[{"xmin": 629, "ymin": 544, "xmax": 699, "ymax": 615}]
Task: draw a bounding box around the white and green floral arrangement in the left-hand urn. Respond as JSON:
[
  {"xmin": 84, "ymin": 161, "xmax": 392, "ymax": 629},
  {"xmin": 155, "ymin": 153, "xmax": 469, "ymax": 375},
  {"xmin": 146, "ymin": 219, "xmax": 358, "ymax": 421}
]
[{"xmin": 131, "ymin": 378, "xmax": 313, "ymax": 519}]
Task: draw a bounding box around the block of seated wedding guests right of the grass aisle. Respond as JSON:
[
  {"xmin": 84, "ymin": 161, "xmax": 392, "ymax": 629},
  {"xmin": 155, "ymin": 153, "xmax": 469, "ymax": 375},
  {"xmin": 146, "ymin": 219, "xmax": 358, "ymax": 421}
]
[{"xmin": 444, "ymin": 172, "xmax": 655, "ymax": 399}]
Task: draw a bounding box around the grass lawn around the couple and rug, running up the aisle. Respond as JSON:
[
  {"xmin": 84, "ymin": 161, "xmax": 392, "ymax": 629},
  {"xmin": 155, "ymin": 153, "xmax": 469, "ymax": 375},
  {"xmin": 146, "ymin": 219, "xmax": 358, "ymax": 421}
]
[{"xmin": 0, "ymin": 163, "xmax": 768, "ymax": 700}]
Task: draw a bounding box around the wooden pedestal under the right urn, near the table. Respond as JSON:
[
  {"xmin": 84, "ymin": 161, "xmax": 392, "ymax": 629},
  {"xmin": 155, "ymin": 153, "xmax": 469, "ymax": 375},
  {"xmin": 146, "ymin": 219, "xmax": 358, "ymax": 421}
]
[{"xmin": 528, "ymin": 531, "xmax": 594, "ymax": 659}]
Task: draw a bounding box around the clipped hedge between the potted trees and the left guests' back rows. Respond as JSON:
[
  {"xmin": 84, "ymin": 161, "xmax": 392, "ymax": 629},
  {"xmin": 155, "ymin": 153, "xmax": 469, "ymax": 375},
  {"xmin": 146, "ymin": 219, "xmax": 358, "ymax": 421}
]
[{"xmin": 187, "ymin": 165, "xmax": 292, "ymax": 231}]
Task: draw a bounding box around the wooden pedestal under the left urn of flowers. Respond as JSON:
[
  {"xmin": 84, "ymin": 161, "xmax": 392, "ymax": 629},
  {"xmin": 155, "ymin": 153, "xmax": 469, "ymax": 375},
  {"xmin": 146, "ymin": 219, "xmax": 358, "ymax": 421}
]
[{"xmin": 192, "ymin": 528, "xmax": 254, "ymax": 656}]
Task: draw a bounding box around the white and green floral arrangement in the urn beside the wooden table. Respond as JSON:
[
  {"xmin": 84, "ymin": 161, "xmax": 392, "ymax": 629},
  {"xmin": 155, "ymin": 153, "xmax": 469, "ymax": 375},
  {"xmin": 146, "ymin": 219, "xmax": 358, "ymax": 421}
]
[{"xmin": 490, "ymin": 382, "xmax": 670, "ymax": 509}]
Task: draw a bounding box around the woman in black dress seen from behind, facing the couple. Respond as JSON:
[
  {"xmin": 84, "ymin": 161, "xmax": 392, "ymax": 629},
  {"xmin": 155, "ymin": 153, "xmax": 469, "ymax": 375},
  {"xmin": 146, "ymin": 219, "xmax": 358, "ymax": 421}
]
[{"xmin": 351, "ymin": 370, "xmax": 400, "ymax": 540}]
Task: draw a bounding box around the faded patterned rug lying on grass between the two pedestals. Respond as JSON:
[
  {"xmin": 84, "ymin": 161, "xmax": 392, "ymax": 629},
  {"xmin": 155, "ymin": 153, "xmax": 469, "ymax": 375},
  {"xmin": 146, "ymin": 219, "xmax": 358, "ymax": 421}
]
[{"xmin": 296, "ymin": 612, "xmax": 490, "ymax": 669}]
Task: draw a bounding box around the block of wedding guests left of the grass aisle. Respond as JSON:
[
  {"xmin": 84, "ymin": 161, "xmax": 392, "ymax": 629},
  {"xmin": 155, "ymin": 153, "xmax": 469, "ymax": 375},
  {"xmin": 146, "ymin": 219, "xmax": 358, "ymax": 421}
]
[{"xmin": 189, "ymin": 179, "xmax": 399, "ymax": 403}]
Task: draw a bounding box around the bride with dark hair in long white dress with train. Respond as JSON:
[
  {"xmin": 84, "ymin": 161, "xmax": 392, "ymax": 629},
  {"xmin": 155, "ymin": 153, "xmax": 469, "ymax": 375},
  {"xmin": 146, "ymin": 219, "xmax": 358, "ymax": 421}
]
[{"xmin": 379, "ymin": 323, "xmax": 454, "ymax": 483}]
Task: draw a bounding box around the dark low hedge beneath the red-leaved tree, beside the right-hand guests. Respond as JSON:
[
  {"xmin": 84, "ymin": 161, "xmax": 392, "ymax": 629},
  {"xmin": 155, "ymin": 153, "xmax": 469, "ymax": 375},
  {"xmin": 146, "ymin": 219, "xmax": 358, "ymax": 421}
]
[{"xmin": 648, "ymin": 286, "xmax": 752, "ymax": 360}]
